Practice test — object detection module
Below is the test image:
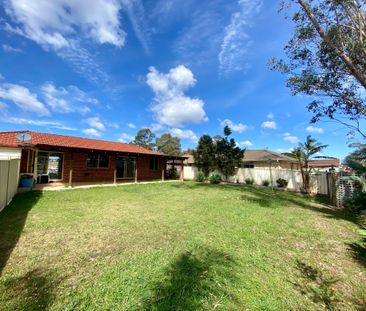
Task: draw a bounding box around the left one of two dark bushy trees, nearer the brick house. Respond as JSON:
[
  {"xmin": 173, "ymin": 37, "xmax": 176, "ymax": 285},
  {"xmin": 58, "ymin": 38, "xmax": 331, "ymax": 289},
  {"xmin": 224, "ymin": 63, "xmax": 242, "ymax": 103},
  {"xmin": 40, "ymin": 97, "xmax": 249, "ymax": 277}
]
[{"xmin": 193, "ymin": 135, "xmax": 216, "ymax": 177}]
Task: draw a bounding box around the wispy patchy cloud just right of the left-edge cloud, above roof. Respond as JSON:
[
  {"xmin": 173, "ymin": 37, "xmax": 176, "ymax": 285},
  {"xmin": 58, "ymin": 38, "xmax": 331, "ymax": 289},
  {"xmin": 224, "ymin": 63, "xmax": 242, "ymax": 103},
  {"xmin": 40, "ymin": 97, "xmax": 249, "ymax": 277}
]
[{"xmin": 41, "ymin": 82, "xmax": 98, "ymax": 114}]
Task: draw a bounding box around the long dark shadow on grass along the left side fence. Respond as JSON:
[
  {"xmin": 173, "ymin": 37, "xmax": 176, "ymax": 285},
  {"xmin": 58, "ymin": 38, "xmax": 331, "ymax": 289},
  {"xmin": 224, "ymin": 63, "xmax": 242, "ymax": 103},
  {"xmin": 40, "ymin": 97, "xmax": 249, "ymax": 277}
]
[{"xmin": 0, "ymin": 191, "xmax": 42, "ymax": 276}]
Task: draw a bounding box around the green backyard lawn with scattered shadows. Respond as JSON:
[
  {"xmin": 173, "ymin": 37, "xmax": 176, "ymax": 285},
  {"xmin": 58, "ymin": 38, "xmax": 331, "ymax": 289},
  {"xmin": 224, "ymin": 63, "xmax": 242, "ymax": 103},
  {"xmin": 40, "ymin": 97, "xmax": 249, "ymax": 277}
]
[{"xmin": 0, "ymin": 182, "xmax": 366, "ymax": 311}]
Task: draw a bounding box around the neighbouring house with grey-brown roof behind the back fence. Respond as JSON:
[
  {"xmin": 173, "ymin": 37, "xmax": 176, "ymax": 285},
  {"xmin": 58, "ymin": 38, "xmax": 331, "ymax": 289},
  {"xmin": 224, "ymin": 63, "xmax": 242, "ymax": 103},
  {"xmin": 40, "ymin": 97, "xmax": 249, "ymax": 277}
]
[{"xmin": 242, "ymin": 149, "xmax": 299, "ymax": 170}]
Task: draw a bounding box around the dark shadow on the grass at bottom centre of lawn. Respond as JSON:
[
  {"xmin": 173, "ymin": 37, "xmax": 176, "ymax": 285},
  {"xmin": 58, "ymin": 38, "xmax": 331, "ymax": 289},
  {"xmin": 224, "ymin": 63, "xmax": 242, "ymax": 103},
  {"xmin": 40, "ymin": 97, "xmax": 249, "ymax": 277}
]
[{"xmin": 142, "ymin": 250, "xmax": 236, "ymax": 311}]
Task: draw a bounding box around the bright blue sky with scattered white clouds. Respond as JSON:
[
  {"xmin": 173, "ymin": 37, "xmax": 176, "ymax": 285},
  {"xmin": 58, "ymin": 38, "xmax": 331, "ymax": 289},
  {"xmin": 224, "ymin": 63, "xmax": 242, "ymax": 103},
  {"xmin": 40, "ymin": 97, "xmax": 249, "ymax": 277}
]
[{"xmin": 0, "ymin": 0, "xmax": 351, "ymax": 158}]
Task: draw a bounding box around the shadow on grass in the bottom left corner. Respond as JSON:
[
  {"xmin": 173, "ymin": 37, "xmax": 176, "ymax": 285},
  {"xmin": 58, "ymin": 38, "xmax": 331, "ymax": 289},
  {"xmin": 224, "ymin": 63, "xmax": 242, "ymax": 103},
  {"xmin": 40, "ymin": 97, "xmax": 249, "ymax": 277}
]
[{"xmin": 0, "ymin": 269, "xmax": 58, "ymax": 311}]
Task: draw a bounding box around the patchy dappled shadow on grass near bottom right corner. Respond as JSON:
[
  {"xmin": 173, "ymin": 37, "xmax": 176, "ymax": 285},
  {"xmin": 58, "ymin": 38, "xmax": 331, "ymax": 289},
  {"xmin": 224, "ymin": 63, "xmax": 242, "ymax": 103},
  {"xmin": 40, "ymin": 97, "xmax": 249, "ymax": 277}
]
[{"xmin": 292, "ymin": 261, "xmax": 338, "ymax": 310}]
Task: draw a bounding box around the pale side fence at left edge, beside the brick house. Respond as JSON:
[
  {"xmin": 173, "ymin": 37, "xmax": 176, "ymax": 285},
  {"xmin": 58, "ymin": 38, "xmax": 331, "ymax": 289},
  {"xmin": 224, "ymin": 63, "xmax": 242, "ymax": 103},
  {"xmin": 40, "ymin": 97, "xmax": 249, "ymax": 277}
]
[{"xmin": 0, "ymin": 153, "xmax": 20, "ymax": 211}]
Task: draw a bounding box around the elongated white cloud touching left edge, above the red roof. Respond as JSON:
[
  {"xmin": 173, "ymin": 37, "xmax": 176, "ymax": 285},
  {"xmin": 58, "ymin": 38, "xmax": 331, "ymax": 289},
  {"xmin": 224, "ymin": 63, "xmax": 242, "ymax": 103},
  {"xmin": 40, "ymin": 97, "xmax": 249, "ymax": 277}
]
[{"xmin": 0, "ymin": 83, "xmax": 50, "ymax": 116}]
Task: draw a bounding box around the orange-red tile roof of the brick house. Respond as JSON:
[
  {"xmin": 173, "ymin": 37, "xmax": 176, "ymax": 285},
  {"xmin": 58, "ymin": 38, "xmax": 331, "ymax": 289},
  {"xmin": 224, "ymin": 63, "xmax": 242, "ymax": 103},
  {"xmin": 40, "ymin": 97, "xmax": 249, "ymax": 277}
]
[{"xmin": 0, "ymin": 131, "xmax": 164, "ymax": 155}]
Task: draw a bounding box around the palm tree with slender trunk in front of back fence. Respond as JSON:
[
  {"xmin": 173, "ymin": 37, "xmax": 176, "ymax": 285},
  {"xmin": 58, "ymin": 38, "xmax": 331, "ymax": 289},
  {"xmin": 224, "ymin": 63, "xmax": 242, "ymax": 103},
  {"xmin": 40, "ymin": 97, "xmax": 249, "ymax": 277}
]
[{"xmin": 287, "ymin": 135, "xmax": 328, "ymax": 193}]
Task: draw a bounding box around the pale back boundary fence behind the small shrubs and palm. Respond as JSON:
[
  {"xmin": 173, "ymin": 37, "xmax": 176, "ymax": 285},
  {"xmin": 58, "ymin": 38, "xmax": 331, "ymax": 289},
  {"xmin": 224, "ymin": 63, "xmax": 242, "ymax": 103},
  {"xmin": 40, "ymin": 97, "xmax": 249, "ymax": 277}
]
[{"xmin": 184, "ymin": 166, "xmax": 328, "ymax": 194}]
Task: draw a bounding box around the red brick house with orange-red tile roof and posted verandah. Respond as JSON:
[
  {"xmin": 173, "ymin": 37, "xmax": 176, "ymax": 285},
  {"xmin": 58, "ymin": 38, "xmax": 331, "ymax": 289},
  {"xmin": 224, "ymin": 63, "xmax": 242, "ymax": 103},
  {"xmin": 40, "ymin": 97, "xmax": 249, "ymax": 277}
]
[{"xmin": 0, "ymin": 131, "xmax": 185, "ymax": 185}]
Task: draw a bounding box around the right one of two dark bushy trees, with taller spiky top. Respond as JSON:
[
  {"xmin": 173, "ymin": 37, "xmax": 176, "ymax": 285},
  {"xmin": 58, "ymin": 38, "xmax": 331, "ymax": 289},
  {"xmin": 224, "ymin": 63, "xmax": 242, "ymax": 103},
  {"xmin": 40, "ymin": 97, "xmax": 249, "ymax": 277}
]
[{"xmin": 216, "ymin": 126, "xmax": 245, "ymax": 180}]
